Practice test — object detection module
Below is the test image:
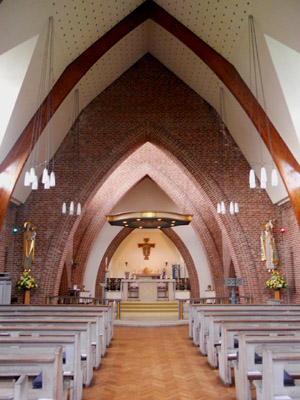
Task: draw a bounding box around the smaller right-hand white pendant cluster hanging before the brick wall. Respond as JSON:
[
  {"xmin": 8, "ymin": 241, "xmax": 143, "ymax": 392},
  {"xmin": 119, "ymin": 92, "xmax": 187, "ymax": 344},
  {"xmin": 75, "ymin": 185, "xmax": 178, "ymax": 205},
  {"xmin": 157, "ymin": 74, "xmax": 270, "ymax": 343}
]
[{"xmin": 217, "ymin": 88, "xmax": 239, "ymax": 215}]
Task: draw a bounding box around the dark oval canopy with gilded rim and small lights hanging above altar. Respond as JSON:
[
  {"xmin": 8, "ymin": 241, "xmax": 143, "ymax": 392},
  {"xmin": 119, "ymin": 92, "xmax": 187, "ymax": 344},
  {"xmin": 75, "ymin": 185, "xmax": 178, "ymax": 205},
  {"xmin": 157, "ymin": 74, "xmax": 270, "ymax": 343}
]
[{"xmin": 106, "ymin": 211, "xmax": 193, "ymax": 229}]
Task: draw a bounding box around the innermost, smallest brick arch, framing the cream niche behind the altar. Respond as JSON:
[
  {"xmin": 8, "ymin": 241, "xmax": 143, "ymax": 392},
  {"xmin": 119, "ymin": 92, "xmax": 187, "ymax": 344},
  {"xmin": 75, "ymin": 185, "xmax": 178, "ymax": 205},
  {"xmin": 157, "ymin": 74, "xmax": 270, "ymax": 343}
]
[{"xmin": 95, "ymin": 228, "xmax": 200, "ymax": 297}]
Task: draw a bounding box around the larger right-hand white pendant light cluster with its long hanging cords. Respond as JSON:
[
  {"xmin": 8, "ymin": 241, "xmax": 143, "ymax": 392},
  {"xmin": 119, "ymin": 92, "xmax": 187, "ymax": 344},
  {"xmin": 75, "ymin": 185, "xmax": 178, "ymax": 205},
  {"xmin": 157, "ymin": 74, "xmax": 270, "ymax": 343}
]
[{"xmin": 248, "ymin": 15, "xmax": 278, "ymax": 189}]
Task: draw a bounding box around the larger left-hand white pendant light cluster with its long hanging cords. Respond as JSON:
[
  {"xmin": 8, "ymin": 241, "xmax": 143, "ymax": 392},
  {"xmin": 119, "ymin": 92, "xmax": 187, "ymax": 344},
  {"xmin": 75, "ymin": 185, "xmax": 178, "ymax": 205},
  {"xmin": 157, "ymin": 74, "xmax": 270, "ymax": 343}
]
[{"xmin": 24, "ymin": 17, "xmax": 56, "ymax": 190}]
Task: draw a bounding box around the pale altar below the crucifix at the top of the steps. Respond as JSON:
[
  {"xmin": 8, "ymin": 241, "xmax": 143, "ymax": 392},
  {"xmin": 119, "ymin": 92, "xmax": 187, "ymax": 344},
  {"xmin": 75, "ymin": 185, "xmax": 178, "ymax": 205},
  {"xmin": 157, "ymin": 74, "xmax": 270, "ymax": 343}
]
[{"xmin": 121, "ymin": 277, "xmax": 176, "ymax": 302}]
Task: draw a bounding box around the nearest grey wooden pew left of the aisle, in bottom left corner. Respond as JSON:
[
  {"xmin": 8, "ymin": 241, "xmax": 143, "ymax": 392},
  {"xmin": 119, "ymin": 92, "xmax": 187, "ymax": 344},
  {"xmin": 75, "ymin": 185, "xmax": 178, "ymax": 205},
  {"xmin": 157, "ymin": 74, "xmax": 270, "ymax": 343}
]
[{"xmin": 0, "ymin": 346, "xmax": 67, "ymax": 400}]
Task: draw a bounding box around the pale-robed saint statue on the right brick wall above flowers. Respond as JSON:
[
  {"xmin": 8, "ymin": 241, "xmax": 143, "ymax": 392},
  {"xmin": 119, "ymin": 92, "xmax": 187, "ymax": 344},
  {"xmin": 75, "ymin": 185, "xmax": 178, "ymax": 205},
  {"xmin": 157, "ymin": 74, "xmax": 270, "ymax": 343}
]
[{"xmin": 260, "ymin": 220, "xmax": 279, "ymax": 271}]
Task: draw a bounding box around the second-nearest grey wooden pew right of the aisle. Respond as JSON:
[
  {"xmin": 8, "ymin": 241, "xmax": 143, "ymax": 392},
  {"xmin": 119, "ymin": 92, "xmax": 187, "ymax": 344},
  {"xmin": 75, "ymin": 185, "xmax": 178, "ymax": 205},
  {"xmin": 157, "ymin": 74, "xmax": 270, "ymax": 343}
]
[{"xmin": 233, "ymin": 334, "xmax": 300, "ymax": 400}]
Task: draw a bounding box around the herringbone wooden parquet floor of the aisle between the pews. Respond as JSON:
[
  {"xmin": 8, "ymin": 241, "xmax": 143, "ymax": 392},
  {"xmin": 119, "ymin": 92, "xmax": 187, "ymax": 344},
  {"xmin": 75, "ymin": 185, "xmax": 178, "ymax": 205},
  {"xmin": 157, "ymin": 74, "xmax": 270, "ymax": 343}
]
[{"xmin": 83, "ymin": 326, "xmax": 235, "ymax": 400}]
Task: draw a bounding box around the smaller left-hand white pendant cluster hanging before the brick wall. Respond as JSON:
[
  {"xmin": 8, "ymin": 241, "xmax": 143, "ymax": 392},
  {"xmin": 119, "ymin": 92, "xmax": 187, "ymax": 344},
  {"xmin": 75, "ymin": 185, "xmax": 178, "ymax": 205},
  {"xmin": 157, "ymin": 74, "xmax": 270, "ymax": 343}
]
[{"xmin": 61, "ymin": 89, "xmax": 82, "ymax": 217}]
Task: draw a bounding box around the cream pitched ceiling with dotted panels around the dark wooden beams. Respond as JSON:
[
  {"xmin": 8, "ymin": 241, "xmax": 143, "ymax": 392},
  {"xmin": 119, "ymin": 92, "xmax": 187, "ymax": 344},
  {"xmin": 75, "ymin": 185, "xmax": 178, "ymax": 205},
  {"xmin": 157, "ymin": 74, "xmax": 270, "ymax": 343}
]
[{"xmin": 0, "ymin": 0, "xmax": 300, "ymax": 202}]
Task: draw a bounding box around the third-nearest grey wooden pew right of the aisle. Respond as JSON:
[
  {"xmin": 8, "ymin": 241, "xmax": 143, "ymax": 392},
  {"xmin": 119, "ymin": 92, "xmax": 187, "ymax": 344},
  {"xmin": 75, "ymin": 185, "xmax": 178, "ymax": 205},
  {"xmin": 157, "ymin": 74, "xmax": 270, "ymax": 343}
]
[{"xmin": 218, "ymin": 321, "xmax": 300, "ymax": 385}]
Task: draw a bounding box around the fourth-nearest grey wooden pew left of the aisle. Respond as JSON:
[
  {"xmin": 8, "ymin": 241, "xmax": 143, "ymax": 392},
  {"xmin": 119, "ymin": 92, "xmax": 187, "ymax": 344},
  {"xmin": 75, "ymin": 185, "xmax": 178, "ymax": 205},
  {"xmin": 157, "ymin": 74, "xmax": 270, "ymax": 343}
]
[{"xmin": 0, "ymin": 314, "xmax": 101, "ymax": 369}]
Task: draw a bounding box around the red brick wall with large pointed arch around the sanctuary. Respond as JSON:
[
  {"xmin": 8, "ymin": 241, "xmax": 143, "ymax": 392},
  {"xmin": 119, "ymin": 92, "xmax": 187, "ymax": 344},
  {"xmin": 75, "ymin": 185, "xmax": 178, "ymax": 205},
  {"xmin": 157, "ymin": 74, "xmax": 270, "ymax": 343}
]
[{"xmin": 0, "ymin": 55, "xmax": 299, "ymax": 302}]
